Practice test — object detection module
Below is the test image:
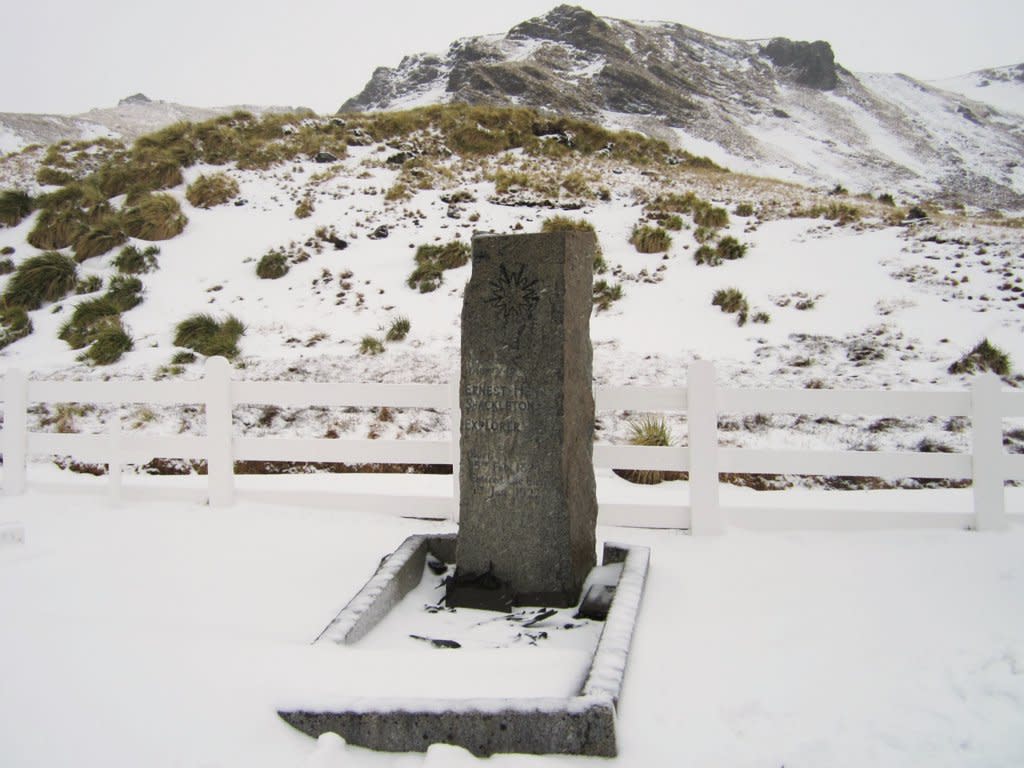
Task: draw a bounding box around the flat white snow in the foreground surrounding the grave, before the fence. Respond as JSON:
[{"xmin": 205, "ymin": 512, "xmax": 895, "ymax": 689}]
[{"xmin": 0, "ymin": 478, "xmax": 1024, "ymax": 768}]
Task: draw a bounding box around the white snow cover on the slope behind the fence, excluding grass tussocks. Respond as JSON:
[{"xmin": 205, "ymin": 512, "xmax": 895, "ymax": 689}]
[{"xmin": 0, "ymin": 134, "xmax": 1024, "ymax": 475}]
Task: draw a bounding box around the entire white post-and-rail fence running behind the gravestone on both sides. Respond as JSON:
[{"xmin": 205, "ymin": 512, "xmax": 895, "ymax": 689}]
[{"xmin": 0, "ymin": 357, "xmax": 1024, "ymax": 534}]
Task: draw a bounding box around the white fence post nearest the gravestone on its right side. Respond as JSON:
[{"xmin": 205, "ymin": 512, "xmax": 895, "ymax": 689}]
[{"xmin": 686, "ymin": 360, "xmax": 725, "ymax": 536}]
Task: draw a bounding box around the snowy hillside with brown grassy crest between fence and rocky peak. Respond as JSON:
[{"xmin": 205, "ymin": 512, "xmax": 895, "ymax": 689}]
[{"xmin": 0, "ymin": 109, "xmax": 1024, "ymax": 487}]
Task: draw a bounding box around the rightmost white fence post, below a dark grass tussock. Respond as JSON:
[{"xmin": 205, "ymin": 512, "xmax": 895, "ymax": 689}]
[{"xmin": 971, "ymin": 374, "xmax": 1008, "ymax": 530}]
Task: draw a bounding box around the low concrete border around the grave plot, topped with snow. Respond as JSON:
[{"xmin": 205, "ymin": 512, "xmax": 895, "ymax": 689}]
[{"xmin": 278, "ymin": 535, "xmax": 650, "ymax": 757}]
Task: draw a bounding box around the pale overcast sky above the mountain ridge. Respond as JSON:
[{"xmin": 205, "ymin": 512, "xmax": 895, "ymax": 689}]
[{"xmin": 0, "ymin": 0, "xmax": 1024, "ymax": 114}]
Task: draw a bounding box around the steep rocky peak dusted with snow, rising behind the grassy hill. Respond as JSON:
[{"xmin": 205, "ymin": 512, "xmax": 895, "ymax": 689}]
[{"xmin": 340, "ymin": 5, "xmax": 1024, "ymax": 209}]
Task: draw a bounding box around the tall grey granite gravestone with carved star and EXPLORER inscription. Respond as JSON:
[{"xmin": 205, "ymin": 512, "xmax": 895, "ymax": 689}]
[{"xmin": 446, "ymin": 231, "xmax": 597, "ymax": 610}]
